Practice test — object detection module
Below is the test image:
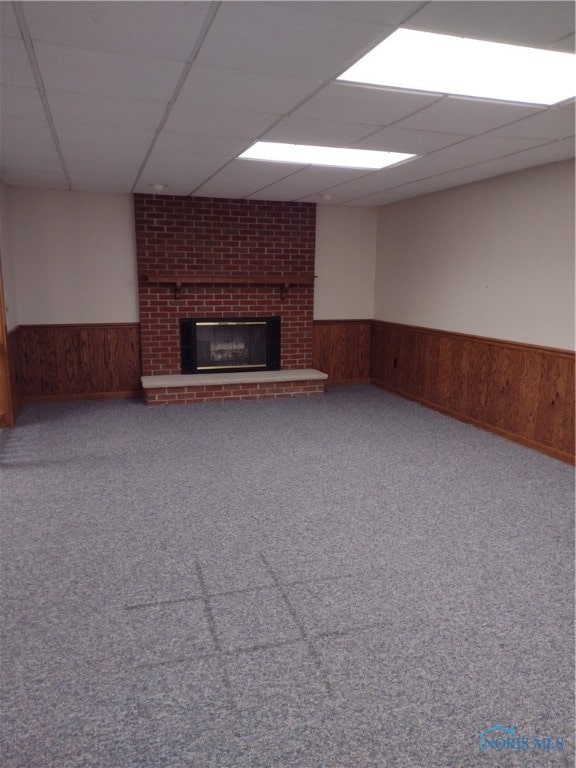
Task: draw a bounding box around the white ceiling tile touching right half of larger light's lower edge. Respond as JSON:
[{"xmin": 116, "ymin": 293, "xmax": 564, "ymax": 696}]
[{"xmin": 395, "ymin": 96, "xmax": 542, "ymax": 136}]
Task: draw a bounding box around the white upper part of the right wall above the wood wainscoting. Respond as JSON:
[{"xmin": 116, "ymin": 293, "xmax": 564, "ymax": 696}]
[{"xmin": 374, "ymin": 161, "xmax": 574, "ymax": 349}]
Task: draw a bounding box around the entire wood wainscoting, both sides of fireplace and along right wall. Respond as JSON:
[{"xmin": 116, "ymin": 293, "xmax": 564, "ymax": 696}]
[{"xmin": 8, "ymin": 320, "xmax": 575, "ymax": 462}]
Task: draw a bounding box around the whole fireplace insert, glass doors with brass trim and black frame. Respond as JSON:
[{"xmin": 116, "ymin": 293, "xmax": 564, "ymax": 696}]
[{"xmin": 180, "ymin": 317, "xmax": 280, "ymax": 374}]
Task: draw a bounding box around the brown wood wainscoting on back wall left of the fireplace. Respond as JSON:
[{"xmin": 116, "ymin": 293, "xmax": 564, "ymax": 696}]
[{"xmin": 9, "ymin": 323, "xmax": 142, "ymax": 405}]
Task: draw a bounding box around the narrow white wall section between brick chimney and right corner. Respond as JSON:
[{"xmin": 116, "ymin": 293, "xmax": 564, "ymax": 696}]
[{"xmin": 314, "ymin": 205, "xmax": 378, "ymax": 320}]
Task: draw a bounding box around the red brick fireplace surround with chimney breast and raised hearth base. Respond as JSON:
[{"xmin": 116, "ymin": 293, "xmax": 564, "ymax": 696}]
[{"xmin": 134, "ymin": 194, "xmax": 324, "ymax": 404}]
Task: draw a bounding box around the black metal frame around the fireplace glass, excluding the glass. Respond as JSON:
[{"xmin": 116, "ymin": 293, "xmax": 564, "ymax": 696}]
[{"xmin": 180, "ymin": 317, "xmax": 281, "ymax": 375}]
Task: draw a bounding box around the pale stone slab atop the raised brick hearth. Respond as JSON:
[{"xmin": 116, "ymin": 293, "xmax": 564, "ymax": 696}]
[{"xmin": 141, "ymin": 368, "xmax": 328, "ymax": 389}]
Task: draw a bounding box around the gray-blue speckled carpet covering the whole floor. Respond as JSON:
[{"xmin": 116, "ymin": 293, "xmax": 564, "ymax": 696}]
[{"xmin": 0, "ymin": 386, "xmax": 574, "ymax": 768}]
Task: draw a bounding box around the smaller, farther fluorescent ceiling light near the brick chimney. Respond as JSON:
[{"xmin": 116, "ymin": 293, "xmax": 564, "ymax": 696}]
[{"xmin": 239, "ymin": 141, "xmax": 415, "ymax": 170}]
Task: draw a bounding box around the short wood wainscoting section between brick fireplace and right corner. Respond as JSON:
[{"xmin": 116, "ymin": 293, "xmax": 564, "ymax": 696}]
[{"xmin": 312, "ymin": 320, "xmax": 372, "ymax": 384}]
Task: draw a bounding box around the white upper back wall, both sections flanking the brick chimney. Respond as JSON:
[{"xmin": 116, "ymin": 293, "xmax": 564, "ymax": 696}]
[{"xmin": 3, "ymin": 192, "xmax": 377, "ymax": 325}]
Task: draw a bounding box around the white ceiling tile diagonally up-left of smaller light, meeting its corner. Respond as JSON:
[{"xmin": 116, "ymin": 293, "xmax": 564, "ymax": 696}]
[{"xmin": 165, "ymin": 104, "xmax": 279, "ymax": 143}]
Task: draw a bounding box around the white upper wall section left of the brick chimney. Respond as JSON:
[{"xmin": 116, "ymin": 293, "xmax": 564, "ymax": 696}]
[{"xmin": 8, "ymin": 188, "xmax": 138, "ymax": 325}]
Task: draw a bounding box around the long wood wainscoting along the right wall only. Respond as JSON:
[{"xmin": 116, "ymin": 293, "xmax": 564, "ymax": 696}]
[{"xmin": 370, "ymin": 321, "xmax": 574, "ymax": 462}]
